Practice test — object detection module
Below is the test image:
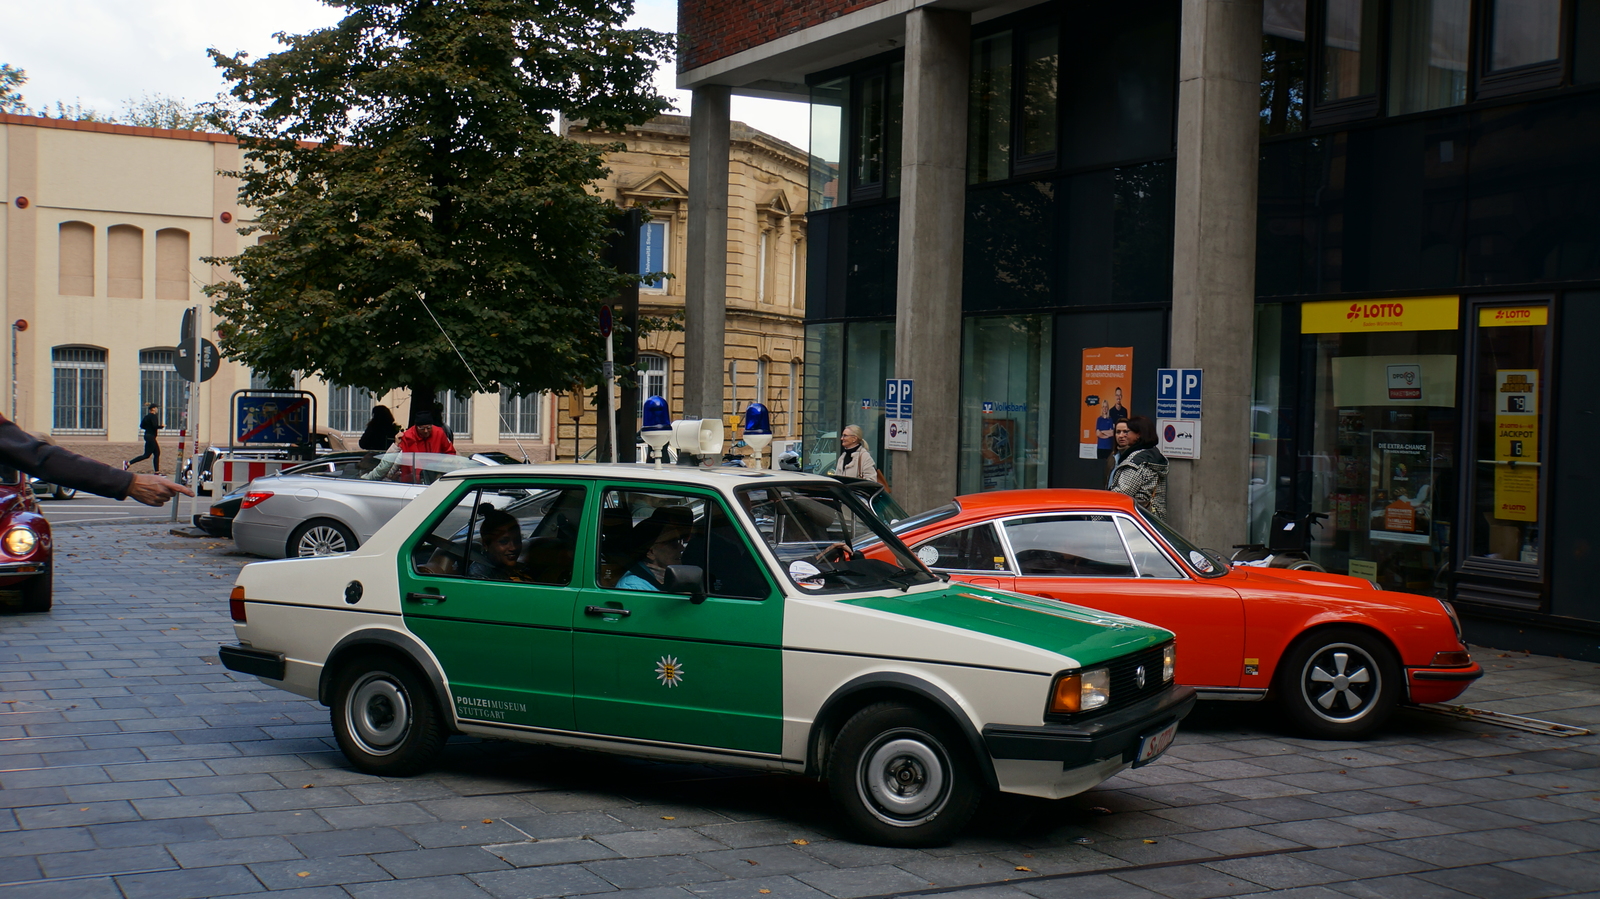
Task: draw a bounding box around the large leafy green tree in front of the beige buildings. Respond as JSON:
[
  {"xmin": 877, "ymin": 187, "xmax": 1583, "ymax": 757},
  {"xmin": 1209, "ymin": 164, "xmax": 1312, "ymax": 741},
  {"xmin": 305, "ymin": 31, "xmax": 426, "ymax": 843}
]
[{"xmin": 208, "ymin": 0, "xmax": 672, "ymax": 413}]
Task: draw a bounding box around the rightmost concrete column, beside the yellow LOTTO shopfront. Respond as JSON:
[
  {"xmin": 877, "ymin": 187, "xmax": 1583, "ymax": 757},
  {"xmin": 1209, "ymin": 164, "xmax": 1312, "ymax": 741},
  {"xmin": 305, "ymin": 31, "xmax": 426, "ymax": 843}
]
[{"xmin": 1166, "ymin": 0, "xmax": 1261, "ymax": 553}]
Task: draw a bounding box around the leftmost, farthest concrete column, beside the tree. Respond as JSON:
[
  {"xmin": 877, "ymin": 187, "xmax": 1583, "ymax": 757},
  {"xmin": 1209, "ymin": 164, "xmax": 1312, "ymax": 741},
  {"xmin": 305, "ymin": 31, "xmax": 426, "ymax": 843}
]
[{"xmin": 683, "ymin": 85, "xmax": 730, "ymax": 418}]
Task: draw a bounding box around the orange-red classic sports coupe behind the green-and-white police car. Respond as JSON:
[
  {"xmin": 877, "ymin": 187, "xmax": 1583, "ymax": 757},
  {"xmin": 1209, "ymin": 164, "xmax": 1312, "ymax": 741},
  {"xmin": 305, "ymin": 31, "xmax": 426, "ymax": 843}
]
[{"xmin": 867, "ymin": 489, "xmax": 1483, "ymax": 739}]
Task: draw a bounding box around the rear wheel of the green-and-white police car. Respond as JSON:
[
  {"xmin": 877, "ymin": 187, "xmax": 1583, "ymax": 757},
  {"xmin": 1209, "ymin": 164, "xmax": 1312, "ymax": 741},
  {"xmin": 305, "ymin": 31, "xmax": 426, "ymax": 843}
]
[{"xmin": 331, "ymin": 646, "xmax": 448, "ymax": 777}]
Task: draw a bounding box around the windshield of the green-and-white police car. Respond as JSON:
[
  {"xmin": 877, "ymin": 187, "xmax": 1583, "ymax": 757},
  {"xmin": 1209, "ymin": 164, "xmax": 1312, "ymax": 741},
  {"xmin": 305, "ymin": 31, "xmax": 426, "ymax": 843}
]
[{"xmin": 738, "ymin": 483, "xmax": 938, "ymax": 593}]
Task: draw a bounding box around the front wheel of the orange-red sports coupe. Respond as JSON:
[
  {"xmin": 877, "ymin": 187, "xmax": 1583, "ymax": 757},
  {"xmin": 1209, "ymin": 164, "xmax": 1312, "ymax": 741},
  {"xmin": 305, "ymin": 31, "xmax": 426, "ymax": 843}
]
[{"xmin": 1277, "ymin": 627, "xmax": 1400, "ymax": 739}]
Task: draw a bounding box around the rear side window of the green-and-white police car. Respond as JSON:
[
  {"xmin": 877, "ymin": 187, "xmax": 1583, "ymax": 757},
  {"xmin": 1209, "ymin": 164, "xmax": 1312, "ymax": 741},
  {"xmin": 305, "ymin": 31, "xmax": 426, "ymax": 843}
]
[{"xmin": 413, "ymin": 485, "xmax": 584, "ymax": 587}]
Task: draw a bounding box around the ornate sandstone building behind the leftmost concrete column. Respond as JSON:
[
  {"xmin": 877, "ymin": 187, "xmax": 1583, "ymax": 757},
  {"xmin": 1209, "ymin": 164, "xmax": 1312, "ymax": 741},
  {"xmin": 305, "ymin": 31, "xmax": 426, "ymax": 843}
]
[{"xmin": 555, "ymin": 115, "xmax": 808, "ymax": 462}]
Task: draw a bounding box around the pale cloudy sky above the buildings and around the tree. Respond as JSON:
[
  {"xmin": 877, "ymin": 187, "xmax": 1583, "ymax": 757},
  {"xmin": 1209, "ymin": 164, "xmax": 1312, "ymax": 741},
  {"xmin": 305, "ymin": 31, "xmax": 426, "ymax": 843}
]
[{"xmin": 0, "ymin": 0, "xmax": 806, "ymax": 147}]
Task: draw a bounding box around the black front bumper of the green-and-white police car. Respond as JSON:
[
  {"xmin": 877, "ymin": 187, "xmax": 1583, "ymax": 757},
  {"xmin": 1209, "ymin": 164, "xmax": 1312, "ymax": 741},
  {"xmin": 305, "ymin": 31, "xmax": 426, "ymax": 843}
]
[{"xmin": 984, "ymin": 685, "xmax": 1195, "ymax": 768}]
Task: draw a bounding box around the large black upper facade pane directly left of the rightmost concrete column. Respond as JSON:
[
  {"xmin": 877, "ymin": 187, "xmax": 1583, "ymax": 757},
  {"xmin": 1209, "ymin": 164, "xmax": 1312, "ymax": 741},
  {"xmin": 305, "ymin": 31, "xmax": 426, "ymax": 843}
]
[{"xmin": 1059, "ymin": 0, "xmax": 1179, "ymax": 170}]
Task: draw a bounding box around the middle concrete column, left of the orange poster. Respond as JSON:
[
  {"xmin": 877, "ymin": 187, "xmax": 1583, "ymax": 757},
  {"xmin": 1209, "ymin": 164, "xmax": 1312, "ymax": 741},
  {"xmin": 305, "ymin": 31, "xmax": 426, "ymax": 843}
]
[{"xmin": 893, "ymin": 6, "xmax": 971, "ymax": 510}]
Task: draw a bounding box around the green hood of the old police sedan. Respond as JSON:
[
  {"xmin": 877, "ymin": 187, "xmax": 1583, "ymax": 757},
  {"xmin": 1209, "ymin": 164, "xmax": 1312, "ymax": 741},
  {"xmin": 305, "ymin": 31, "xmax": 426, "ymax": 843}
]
[{"xmin": 840, "ymin": 584, "xmax": 1171, "ymax": 664}]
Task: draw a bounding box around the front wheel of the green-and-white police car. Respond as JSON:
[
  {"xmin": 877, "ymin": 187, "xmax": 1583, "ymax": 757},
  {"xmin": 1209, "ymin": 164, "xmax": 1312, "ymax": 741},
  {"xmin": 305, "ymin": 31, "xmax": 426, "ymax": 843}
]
[{"xmin": 827, "ymin": 702, "xmax": 982, "ymax": 846}]
